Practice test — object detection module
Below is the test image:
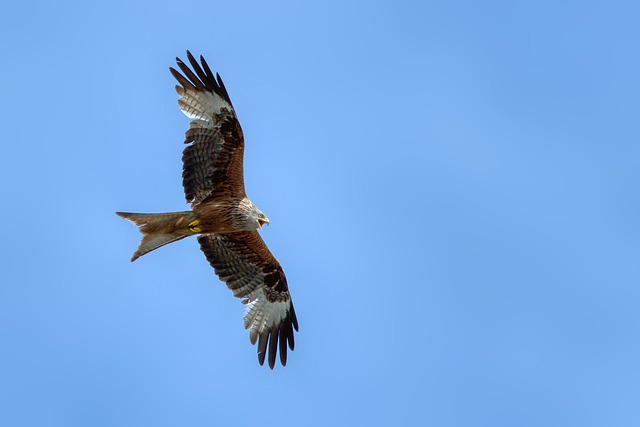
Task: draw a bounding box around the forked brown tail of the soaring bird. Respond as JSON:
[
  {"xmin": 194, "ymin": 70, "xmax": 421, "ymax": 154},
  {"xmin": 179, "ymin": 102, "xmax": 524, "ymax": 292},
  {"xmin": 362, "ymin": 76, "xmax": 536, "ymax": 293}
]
[{"xmin": 116, "ymin": 211, "xmax": 194, "ymax": 262}]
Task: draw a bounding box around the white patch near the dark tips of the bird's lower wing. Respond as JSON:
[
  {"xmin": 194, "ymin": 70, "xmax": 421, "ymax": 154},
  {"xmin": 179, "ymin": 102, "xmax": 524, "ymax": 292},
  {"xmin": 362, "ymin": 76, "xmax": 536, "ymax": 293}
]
[{"xmin": 244, "ymin": 286, "xmax": 291, "ymax": 344}]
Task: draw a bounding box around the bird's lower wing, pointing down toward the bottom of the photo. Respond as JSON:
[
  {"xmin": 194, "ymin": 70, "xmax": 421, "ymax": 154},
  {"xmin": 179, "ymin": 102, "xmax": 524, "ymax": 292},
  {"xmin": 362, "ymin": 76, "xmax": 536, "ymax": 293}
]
[{"xmin": 198, "ymin": 231, "xmax": 298, "ymax": 369}]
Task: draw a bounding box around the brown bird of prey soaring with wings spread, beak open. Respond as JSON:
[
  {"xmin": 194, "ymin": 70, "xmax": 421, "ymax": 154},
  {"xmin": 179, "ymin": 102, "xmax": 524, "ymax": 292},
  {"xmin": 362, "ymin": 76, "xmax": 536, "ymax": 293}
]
[{"xmin": 116, "ymin": 51, "xmax": 298, "ymax": 369}]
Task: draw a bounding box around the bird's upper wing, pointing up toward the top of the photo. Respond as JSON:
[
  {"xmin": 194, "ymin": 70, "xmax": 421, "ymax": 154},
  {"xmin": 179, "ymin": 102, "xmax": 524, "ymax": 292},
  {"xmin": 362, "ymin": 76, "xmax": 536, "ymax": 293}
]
[{"xmin": 169, "ymin": 51, "xmax": 245, "ymax": 206}]
